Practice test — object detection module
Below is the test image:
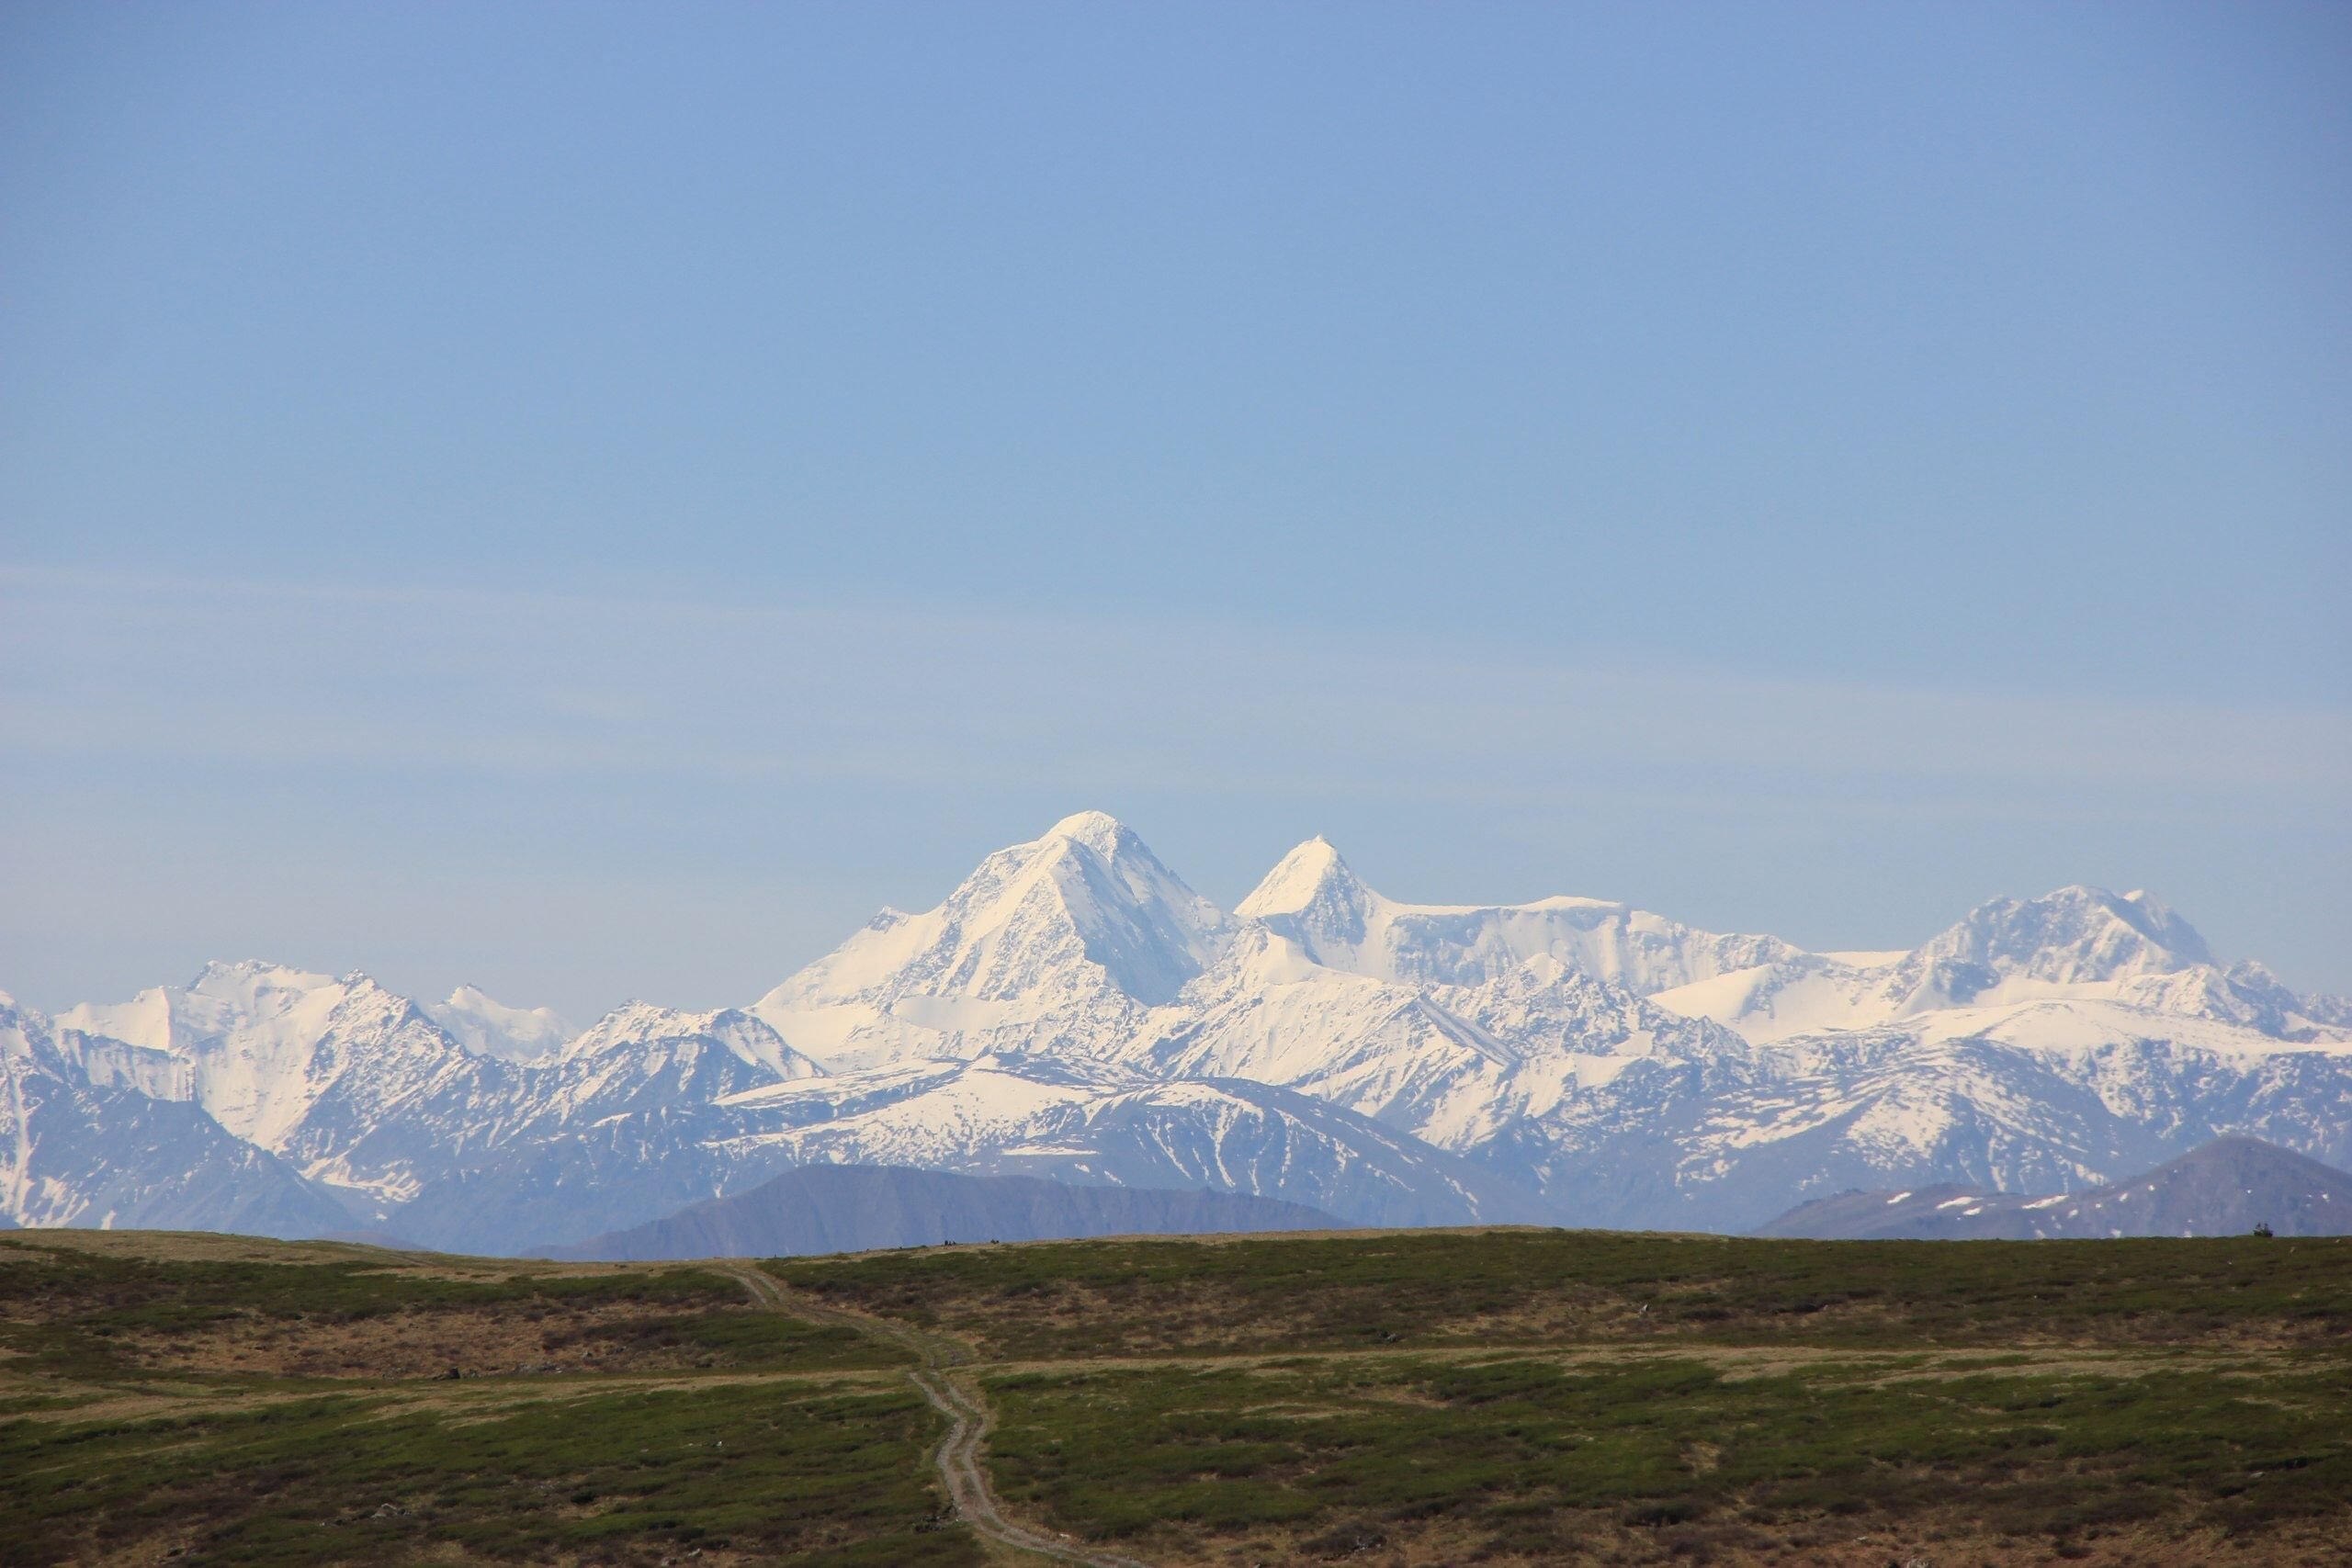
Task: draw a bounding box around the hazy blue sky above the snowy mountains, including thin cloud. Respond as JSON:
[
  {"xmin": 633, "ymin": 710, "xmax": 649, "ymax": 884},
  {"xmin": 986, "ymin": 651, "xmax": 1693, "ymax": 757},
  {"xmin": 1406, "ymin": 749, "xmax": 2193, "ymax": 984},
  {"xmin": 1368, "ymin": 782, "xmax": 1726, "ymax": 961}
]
[{"xmin": 0, "ymin": 3, "xmax": 2352, "ymax": 1016}]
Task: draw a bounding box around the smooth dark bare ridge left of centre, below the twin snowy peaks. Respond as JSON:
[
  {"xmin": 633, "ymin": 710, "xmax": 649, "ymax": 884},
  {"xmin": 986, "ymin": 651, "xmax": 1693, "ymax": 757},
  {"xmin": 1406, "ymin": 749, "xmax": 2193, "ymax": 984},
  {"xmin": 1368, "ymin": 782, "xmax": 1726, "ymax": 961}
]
[{"xmin": 532, "ymin": 1166, "xmax": 1345, "ymax": 1262}]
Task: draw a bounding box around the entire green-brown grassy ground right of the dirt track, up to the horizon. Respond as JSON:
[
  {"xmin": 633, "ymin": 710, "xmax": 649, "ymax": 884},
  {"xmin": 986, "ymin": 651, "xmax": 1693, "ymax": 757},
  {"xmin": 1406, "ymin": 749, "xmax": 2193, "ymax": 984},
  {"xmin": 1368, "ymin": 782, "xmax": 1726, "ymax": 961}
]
[{"xmin": 767, "ymin": 1229, "xmax": 2352, "ymax": 1568}]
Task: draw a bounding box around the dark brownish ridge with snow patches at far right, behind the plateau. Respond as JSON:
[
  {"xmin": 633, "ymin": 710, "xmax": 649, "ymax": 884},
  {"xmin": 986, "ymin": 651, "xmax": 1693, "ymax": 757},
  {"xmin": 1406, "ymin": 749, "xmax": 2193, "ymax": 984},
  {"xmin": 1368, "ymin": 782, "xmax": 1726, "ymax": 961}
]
[{"xmin": 1755, "ymin": 1138, "xmax": 2352, "ymax": 1241}]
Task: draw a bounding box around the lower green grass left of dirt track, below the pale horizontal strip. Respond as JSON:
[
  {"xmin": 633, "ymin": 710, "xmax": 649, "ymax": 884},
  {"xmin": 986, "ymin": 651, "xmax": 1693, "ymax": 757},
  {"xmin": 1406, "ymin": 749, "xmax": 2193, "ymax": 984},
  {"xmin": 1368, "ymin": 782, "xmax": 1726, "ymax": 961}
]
[{"xmin": 0, "ymin": 1384, "xmax": 978, "ymax": 1568}]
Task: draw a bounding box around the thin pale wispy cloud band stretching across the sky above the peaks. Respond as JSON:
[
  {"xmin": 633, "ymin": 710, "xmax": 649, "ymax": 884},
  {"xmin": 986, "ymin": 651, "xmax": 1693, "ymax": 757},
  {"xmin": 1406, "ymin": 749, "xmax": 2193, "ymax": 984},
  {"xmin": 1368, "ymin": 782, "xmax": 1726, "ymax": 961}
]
[{"xmin": 0, "ymin": 569, "xmax": 2352, "ymax": 808}]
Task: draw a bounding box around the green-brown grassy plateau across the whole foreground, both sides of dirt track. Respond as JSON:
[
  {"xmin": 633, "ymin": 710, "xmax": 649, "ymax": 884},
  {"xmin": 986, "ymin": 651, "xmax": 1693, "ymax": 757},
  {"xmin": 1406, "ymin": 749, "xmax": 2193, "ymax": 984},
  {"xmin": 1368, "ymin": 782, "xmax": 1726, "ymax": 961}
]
[{"xmin": 0, "ymin": 1229, "xmax": 2352, "ymax": 1568}]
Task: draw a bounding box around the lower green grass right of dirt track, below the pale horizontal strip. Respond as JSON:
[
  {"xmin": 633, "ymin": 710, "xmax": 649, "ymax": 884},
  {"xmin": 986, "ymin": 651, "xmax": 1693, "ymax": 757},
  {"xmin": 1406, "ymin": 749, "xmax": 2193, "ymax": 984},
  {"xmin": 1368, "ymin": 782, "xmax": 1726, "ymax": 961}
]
[{"xmin": 988, "ymin": 1354, "xmax": 2352, "ymax": 1561}]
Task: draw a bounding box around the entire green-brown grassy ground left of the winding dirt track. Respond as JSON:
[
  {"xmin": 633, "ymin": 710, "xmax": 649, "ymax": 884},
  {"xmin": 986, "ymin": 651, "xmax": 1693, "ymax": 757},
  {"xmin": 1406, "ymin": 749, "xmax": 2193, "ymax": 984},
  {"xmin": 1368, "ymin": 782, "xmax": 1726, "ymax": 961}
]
[{"xmin": 0, "ymin": 1235, "xmax": 959, "ymax": 1565}]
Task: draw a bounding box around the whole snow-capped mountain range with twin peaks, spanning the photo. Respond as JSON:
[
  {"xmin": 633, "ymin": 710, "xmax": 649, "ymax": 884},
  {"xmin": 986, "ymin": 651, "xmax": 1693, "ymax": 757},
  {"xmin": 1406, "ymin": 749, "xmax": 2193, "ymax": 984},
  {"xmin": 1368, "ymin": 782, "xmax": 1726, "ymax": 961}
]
[{"xmin": 0, "ymin": 811, "xmax": 2352, "ymax": 1251}]
